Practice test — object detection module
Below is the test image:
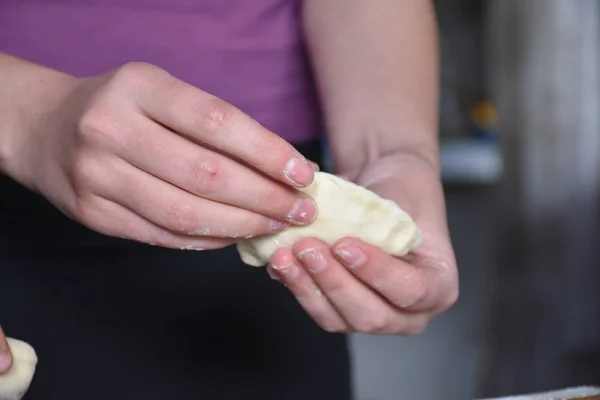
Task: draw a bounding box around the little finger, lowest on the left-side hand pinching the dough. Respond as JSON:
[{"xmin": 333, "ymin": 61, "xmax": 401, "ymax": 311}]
[{"xmin": 78, "ymin": 197, "xmax": 234, "ymax": 250}]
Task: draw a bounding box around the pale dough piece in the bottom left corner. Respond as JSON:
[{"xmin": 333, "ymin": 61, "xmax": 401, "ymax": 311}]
[{"xmin": 0, "ymin": 338, "xmax": 38, "ymax": 400}]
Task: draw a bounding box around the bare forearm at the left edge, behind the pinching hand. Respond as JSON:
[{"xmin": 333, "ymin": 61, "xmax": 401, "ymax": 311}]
[{"xmin": 0, "ymin": 53, "xmax": 74, "ymax": 175}]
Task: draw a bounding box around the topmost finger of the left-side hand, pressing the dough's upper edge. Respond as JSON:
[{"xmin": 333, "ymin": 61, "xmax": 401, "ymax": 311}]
[{"xmin": 136, "ymin": 77, "xmax": 313, "ymax": 187}]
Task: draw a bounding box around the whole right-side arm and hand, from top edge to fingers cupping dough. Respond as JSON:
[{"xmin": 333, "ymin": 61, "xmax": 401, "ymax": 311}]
[{"xmin": 267, "ymin": 0, "xmax": 458, "ymax": 335}]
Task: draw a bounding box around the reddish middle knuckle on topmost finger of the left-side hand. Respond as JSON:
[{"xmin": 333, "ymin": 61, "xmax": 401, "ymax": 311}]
[{"xmin": 190, "ymin": 98, "xmax": 238, "ymax": 133}]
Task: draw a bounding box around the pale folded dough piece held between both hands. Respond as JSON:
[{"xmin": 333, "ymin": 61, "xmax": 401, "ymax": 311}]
[{"xmin": 237, "ymin": 172, "xmax": 421, "ymax": 267}]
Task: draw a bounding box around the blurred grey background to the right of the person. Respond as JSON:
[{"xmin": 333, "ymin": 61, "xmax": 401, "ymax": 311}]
[{"xmin": 352, "ymin": 0, "xmax": 600, "ymax": 400}]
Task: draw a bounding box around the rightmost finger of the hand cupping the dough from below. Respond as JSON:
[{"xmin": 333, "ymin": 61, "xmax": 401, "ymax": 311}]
[{"xmin": 333, "ymin": 238, "xmax": 439, "ymax": 311}]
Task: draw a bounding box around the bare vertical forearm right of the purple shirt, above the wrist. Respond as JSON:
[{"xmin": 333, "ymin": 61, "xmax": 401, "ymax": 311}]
[{"xmin": 303, "ymin": 0, "xmax": 438, "ymax": 172}]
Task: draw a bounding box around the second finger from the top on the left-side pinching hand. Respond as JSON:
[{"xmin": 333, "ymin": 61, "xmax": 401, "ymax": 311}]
[{"xmin": 116, "ymin": 118, "xmax": 317, "ymax": 225}]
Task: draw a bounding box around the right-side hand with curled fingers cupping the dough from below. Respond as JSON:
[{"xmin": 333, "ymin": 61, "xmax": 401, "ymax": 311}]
[{"xmin": 267, "ymin": 152, "xmax": 458, "ymax": 335}]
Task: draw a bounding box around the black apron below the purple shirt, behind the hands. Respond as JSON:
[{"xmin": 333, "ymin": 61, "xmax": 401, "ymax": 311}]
[{"xmin": 0, "ymin": 143, "xmax": 351, "ymax": 400}]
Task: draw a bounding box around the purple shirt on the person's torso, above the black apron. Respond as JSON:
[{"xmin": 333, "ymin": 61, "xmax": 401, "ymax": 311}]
[{"xmin": 0, "ymin": 0, "xmax": 319, "ymax": 142}]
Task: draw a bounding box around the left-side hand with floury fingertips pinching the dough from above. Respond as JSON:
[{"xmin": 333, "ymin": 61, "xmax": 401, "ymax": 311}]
[{"xmin": 12, "ymin": 63, "xmax": 316, "ymax": 249}]
